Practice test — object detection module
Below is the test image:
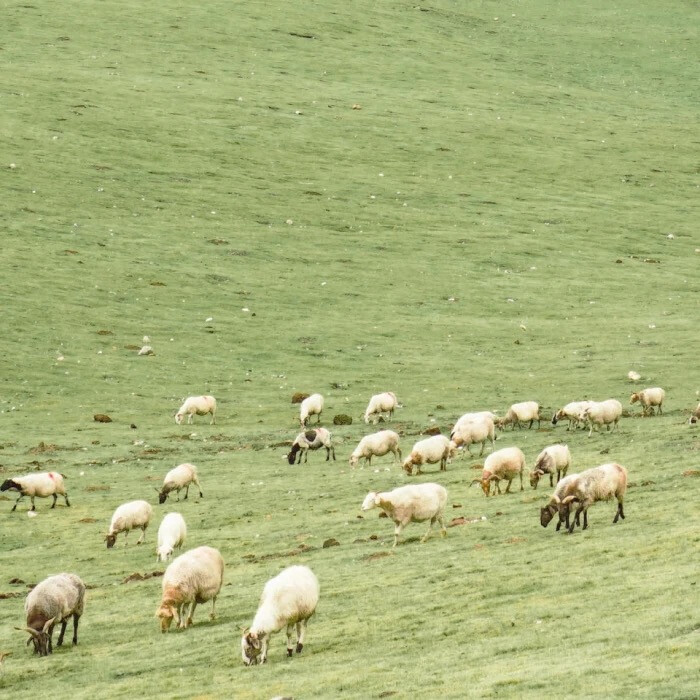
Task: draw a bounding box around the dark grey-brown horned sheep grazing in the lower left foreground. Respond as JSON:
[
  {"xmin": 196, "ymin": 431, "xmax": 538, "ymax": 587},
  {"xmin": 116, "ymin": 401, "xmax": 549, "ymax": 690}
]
[{"xmin": 15, "ymin": 573, "xmax": 85, "ymax": 656}]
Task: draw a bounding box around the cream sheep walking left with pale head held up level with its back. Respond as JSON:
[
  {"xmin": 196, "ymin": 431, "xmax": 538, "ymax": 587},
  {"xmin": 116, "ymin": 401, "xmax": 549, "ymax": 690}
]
[{"xmin": 362, "ymin": 483, "xmax": 447, "ymax": 547}]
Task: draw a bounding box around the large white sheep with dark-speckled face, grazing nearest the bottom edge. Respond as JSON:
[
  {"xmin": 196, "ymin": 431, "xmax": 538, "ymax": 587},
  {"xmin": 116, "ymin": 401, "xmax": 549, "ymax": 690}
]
[{"xmin": 241, "ymin": 565, "xmax": 320, "ymax": 666}]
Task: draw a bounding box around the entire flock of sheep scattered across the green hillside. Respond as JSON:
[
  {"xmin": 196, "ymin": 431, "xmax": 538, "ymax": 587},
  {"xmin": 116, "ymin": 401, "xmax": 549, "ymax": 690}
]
[{"xmin": 0, "ymin": 387, "xmax": 700, "ymax": 665}]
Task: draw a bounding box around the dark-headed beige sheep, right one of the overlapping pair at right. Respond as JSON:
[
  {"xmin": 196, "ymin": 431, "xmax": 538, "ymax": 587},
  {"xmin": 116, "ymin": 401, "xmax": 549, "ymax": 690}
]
[{"xmin": 559, "ymin": 462, "xmax": 627, "ymax": 533}]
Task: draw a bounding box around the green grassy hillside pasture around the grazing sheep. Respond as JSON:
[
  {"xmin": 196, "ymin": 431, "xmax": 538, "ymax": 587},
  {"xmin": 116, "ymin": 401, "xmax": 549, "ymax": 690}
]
[{"xmin": 0, "ymin": 0, "xmax": 700, "ymax": 700}]
